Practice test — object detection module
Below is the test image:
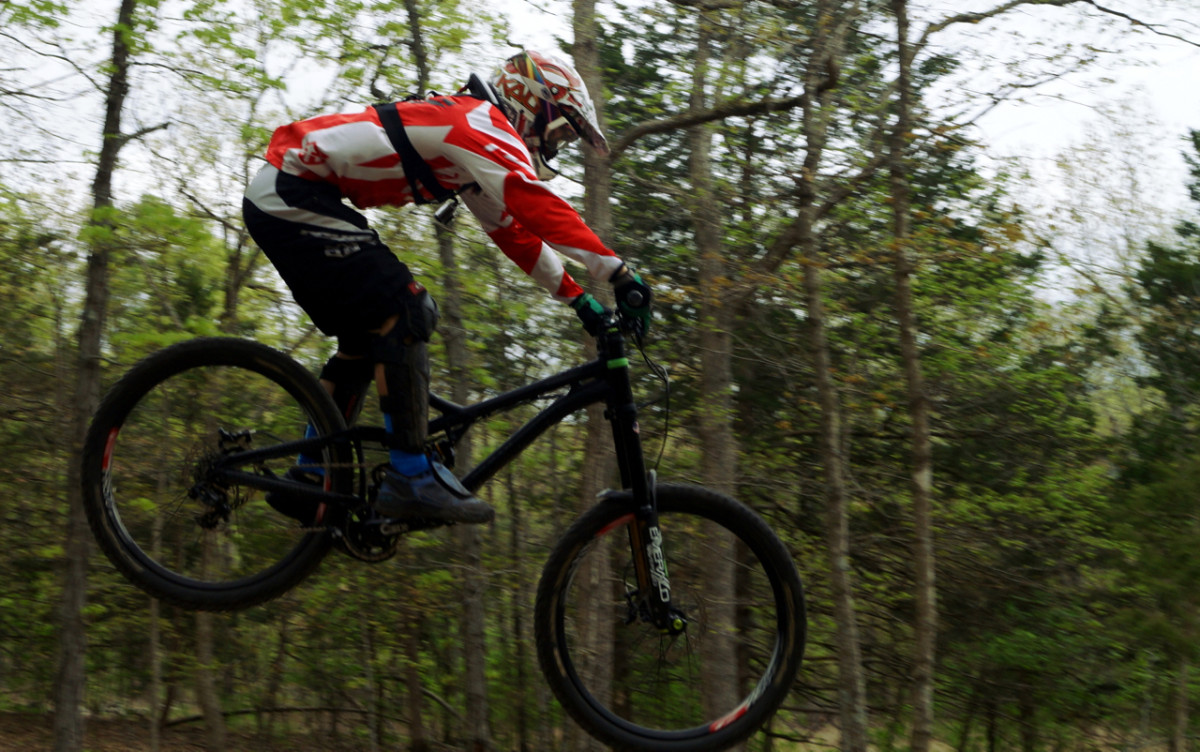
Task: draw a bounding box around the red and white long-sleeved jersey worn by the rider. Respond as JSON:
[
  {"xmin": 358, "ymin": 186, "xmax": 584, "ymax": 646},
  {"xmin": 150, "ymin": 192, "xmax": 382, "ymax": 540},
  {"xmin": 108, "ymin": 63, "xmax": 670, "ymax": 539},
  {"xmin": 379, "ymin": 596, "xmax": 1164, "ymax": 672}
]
[{"xmin": 247, "ymin": 96, "xmax": 622, "ymax": 301}]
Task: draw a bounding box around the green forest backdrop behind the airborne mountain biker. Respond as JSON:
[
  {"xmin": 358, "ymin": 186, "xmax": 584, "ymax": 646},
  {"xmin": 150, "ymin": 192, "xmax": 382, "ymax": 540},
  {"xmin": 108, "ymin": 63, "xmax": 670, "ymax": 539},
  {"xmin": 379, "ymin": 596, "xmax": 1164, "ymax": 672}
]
[{"xmin": 7, "ymin": 0, "xmax": 1200, "ymax": 752}]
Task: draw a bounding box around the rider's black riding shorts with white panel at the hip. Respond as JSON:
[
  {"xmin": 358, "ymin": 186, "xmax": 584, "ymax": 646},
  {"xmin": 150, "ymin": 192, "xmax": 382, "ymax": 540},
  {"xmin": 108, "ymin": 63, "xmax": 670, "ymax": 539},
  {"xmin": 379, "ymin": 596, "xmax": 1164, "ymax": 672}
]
[{"xmin": 242, "ymin": 173, "xmax": 413, "ymax": 341}]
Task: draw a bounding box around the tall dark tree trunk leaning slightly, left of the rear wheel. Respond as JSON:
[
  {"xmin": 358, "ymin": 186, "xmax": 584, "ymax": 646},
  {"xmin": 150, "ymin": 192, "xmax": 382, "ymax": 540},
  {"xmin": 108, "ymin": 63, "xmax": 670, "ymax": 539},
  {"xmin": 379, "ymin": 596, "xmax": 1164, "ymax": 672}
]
[{"xmin": 54, "ymin": 0, "xmax": 137, "ymax": 752}]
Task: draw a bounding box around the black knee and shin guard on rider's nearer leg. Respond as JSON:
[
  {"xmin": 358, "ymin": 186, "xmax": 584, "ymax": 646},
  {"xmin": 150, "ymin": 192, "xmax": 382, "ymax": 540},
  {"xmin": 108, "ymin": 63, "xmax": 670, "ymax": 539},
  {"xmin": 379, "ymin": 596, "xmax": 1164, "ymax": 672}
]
[{"xmin": 372, "ymin": 325, "xmax": 430, "ymax": 453}]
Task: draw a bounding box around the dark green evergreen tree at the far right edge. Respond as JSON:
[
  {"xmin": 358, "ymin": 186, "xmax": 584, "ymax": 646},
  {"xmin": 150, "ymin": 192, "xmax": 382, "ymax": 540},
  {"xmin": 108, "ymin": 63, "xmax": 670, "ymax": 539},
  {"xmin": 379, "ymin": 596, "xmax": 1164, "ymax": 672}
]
[{"xmin": 1114, "ymin": 131, "xmax": 1200, "ymax": 695}]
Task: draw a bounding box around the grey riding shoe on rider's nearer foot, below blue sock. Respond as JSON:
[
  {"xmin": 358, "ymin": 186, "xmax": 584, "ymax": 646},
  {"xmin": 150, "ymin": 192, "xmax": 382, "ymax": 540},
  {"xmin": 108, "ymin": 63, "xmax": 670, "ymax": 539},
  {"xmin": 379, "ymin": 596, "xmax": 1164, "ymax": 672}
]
[{"xmin": 376, "ymin": 462, "xmax": 496, "ymax": 524}]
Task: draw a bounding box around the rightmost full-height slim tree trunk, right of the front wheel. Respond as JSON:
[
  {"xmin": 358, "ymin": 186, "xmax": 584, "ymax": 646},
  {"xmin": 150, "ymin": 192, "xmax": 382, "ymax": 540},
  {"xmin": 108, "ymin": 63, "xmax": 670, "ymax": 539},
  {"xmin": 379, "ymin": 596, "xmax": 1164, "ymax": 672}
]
[{"xmin": 888, "ymin": 0, "xmax": 937, "ymax": 752}]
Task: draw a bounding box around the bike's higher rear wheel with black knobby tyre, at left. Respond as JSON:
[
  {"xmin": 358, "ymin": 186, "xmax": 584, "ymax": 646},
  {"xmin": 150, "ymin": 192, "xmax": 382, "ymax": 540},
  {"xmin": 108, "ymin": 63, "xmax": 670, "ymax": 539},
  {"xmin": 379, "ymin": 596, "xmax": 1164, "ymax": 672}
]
[{"xmin": 83, "ymin": 338, "xmax": 353, "ymax": 610}]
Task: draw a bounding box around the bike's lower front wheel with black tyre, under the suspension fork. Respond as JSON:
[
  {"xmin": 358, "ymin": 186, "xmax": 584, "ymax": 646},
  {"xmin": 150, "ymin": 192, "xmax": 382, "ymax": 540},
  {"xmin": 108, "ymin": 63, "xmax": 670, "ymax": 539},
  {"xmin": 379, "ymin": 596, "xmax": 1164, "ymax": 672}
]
[{"xmin": 534, "ymin": 485, "xmax": 805, "ymax": 752}]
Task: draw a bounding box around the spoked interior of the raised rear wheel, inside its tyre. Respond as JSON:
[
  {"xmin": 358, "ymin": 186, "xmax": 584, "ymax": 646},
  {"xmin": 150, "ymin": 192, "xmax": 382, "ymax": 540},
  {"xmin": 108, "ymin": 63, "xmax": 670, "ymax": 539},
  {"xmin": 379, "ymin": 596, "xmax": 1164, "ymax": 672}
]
[{"xmin": 100, "ymin": 366, "xmax": 324, "ymax": 583}]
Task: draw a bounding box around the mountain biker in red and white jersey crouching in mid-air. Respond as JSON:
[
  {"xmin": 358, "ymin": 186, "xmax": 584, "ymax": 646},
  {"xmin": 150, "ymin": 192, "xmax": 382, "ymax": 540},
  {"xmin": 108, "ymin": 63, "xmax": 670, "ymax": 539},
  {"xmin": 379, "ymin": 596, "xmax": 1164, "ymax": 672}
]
[{"xmin": 242, "ymin": 50, "xmax": 650, "ymax": 524}]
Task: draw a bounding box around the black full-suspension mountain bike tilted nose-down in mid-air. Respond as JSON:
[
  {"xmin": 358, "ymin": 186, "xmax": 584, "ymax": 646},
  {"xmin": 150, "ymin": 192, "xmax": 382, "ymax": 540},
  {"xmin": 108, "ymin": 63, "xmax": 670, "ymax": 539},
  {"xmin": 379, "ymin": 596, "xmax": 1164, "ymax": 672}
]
[{"xmin": 83, "ymin": 314, "xmax": 805, "ymax": 752}]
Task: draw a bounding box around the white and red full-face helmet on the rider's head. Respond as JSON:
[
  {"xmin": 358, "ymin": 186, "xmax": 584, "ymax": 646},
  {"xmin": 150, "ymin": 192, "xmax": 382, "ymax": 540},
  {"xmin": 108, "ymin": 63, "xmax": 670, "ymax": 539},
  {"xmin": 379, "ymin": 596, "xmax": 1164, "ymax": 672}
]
[{"xmin": 491, "ymin": 49, "xmax": 608, "ymax": 178}]
